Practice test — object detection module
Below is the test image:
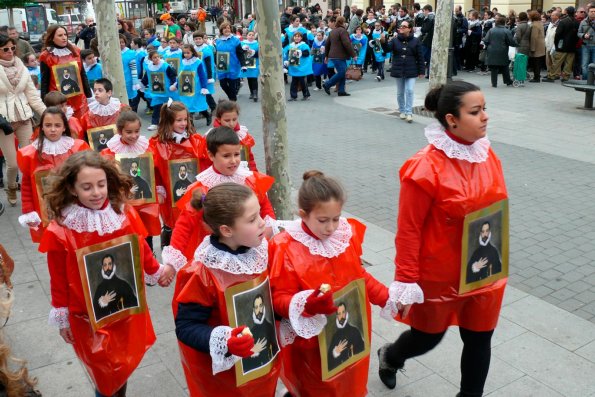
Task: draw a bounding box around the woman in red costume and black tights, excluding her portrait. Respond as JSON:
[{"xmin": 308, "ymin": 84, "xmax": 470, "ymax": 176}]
[{"xmin": 378, "ymin": 81, "xmax": 507, "ymax": 397}]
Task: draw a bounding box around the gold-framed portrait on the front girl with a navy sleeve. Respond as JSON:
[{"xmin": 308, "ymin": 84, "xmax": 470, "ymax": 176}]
[{"xmin": 225, "ymin": 274, "xmax": 280, "ymax": 387}]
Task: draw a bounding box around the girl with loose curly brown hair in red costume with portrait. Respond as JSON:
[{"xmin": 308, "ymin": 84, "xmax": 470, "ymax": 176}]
[{"xmin": 39, "ymin": 150, "xmax": 163, "ymax": 396}]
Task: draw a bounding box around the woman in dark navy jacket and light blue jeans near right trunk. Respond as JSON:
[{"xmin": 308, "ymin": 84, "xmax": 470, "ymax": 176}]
[{"xmin": 388, "ymin": 21, "xmax": 425, "ymax": 123}]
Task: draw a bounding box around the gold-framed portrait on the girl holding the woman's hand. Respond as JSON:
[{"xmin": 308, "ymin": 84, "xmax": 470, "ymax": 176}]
[{"xmin": 318, "ymin": 279, "xmax": 370, "ymax": 380}]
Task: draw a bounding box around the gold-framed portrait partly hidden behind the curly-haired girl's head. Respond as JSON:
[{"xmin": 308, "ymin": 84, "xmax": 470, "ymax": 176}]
[{"xmin": 116, "ymin": 152, "xmax": 157, "ymax": 205}]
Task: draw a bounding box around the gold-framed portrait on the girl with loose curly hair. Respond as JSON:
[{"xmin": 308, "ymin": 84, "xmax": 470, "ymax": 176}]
[{"xmin": 76, "ymin": 234, "xmax": 147, "ymax": 331}]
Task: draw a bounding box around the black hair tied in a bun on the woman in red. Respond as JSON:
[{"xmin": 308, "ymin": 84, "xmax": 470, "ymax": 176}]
[{"xmin": 424, "ymin": 81, "xmax": 480, "ymax": 129}]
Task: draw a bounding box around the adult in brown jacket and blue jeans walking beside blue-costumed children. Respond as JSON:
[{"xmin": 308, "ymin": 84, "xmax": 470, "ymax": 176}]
[{"xmin": 322, "ymin": 17, "xmax": 357, "ymax": 96}]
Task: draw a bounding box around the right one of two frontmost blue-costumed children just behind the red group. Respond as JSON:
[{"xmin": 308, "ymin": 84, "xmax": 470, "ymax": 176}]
[{"xmin": 178, "ymin": 44, "xmax": 211, "ymax": 125}]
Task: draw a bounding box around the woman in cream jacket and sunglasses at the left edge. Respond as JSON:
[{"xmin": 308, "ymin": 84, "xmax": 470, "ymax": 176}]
[{"xmin": 0, "ymin": 35, "xmax": 45, "ymax": 207}]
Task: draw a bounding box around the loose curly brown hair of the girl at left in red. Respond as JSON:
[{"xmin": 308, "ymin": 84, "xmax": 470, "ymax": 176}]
[{"xmin": 46, "ymin": 150, "xmax": 133, "ymax": 219}]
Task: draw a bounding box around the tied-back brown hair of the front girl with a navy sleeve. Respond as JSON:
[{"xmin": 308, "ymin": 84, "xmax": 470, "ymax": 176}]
[{"xmin": 190, "ymin": 183, "xmax": 254, "ymax": 237}]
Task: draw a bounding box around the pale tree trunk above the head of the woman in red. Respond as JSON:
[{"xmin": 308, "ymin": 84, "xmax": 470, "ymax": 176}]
[{"xmin": 430, "ymin": 0, "xmax": 454, "ymax": 88}]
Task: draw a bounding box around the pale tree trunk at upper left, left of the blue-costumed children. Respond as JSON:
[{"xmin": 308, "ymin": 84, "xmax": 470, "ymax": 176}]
[{"xmin": 91, "ymin": 0, "xmax": 128, "ymax": 104}]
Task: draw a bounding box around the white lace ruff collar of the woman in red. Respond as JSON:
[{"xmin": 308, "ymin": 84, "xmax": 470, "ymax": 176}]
[{"xmin": 425, "ymin": 123, "xmax": 490, "ymax": 163}]
